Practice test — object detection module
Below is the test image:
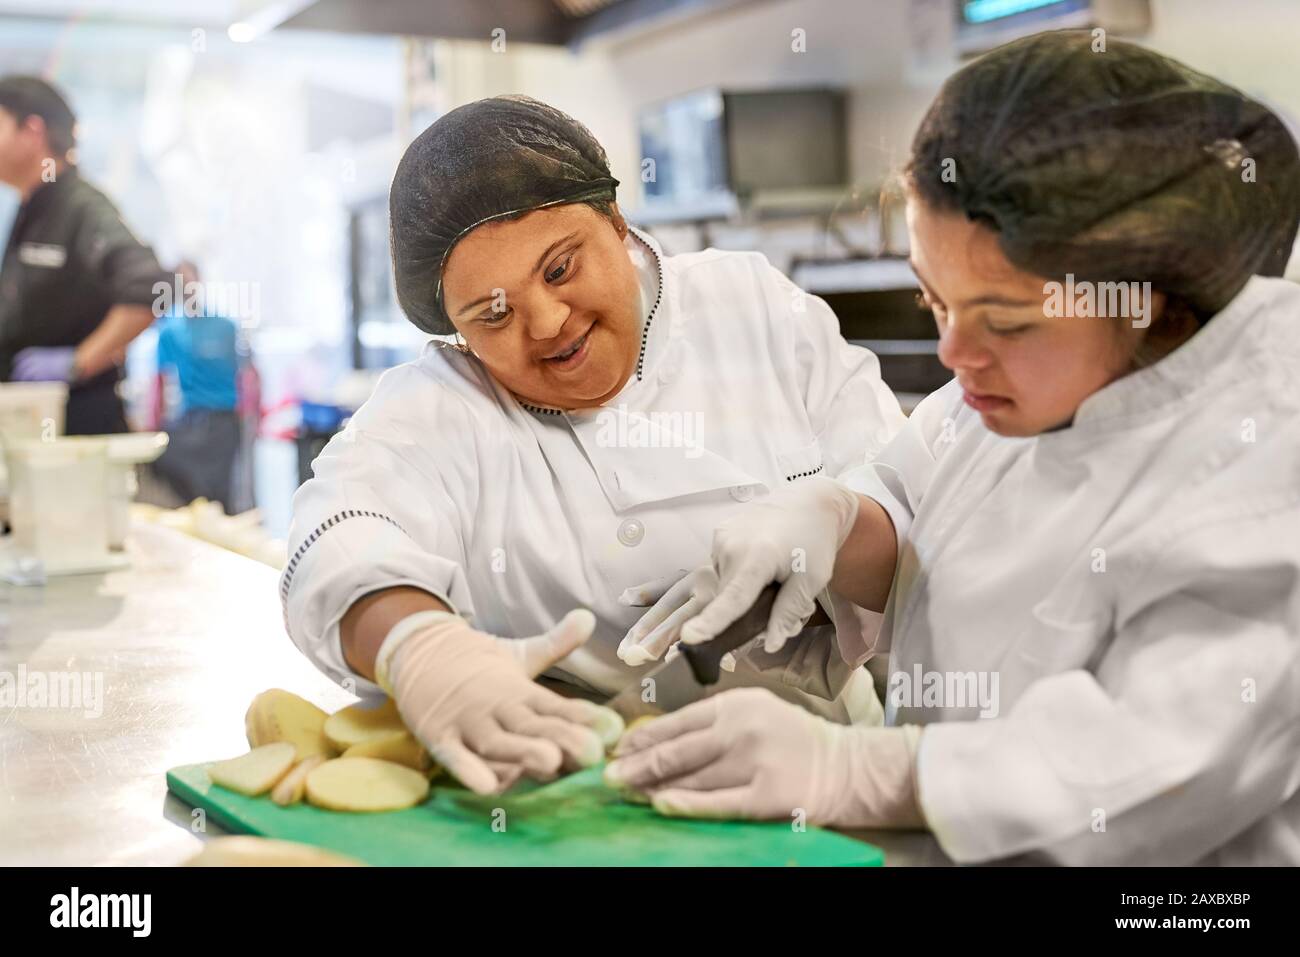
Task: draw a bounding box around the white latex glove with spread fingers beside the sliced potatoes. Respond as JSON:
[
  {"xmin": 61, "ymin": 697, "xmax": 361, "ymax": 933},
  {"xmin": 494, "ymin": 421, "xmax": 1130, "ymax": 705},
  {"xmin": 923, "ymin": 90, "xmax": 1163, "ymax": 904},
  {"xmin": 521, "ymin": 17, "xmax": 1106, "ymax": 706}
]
[{"xmin": 376, "ymin": 609, "xmax": 623, "ymax": 794}]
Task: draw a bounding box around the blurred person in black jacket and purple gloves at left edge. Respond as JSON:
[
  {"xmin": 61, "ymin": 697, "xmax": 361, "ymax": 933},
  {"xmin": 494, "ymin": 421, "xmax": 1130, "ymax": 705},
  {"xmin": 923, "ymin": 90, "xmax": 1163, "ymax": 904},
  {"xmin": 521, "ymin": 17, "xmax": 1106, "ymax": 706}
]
[{"xmin": 0, "ymin": 75, "xmax": 164, "ymax": 434}]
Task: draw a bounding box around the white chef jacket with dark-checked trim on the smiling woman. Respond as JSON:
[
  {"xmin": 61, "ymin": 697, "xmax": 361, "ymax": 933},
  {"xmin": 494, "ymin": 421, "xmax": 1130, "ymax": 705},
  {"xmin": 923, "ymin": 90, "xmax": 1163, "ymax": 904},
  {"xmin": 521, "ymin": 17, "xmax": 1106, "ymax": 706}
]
[{"xmin": 281, "ymin": 230, "xmax": 905, "ymax": 723}]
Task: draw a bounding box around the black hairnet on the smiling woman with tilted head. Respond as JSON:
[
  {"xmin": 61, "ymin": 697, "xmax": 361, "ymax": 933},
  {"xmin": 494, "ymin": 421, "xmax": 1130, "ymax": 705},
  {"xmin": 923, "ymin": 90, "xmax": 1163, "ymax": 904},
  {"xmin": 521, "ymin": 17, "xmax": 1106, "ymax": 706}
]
[{"xmin": 389, "ymin": 96, "xmax": 619, "ymax": 334}]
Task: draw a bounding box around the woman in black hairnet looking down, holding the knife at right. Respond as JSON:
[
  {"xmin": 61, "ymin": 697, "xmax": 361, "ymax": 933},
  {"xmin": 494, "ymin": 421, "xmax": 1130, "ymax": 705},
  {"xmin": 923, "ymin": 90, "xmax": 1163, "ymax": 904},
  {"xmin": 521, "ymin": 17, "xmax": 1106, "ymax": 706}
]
[{"xmin": 607, "ymin": 33, "xmax": 1300, "ymax": 865}]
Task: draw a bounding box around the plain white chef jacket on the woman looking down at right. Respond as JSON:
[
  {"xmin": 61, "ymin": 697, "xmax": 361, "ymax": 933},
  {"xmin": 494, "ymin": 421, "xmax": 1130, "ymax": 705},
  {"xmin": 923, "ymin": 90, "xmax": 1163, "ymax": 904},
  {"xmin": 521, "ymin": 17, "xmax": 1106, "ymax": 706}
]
[{"xmin": 845, "ymin": 277, "xmax": 1300, "ymax": 865}]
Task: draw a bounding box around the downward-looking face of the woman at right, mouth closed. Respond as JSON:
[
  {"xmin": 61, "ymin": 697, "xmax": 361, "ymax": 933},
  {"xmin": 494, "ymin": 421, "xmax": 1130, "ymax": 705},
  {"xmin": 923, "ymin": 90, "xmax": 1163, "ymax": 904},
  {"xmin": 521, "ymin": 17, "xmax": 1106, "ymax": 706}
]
[{"xmin": 907, "ymin": 196, "xmax": 1164, "ymax": 436}]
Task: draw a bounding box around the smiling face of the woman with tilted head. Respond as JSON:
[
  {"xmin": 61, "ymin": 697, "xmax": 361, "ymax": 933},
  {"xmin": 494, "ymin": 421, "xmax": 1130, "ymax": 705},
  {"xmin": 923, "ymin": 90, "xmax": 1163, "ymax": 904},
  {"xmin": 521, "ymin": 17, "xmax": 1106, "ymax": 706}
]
[{"xmin": 442, "ymin": 204, "xmax": 641, "ymax": 410}]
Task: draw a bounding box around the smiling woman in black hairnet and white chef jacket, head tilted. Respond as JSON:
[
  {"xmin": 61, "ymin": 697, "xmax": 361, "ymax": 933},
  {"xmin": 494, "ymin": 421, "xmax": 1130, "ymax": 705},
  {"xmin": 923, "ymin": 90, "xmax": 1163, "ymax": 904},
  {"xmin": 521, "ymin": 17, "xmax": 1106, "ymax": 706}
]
[{"xmin": 281, "ymin": 96, "xmax": 904, "ymax": 792}]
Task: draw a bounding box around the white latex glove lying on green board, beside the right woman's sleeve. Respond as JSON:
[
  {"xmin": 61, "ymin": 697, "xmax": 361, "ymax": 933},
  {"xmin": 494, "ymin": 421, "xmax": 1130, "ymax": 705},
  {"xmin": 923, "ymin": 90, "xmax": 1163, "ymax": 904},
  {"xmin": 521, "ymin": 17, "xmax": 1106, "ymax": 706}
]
[{"xmin": 605, "ymin": 688, "xmax": 924, "ymax": 828}]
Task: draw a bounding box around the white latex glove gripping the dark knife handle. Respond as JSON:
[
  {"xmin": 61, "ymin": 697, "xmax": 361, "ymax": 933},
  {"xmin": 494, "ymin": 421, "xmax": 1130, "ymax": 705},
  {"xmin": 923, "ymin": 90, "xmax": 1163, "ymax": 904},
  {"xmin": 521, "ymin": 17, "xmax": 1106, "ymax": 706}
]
[{"xmin": 681, "ymin": 476, "xmax": 858, "ymax": 653}]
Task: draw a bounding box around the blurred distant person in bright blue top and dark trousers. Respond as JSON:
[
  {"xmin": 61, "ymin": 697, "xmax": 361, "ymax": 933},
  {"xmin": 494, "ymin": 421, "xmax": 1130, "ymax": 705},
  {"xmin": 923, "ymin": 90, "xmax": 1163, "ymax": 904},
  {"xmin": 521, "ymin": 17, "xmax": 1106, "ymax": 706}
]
[{"xmin": 153, "ymin": 261, "xmax": 241, "ymax": 514}]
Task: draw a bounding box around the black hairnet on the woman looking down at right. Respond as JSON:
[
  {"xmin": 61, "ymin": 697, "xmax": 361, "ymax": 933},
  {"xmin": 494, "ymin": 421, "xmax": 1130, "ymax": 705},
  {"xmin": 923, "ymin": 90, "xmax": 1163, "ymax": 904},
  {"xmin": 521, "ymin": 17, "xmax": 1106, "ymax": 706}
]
[{"xmin": 909, "ymin": 31, "xmax": 1300, "ymax": 319}]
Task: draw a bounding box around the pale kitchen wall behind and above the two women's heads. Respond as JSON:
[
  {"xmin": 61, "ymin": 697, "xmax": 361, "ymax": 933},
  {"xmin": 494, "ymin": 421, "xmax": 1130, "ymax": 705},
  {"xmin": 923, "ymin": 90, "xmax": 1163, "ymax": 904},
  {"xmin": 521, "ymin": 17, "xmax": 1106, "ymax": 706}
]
[{"xmin": 439, "ymin": 0, "xmax": 1300, "ymax": 207}]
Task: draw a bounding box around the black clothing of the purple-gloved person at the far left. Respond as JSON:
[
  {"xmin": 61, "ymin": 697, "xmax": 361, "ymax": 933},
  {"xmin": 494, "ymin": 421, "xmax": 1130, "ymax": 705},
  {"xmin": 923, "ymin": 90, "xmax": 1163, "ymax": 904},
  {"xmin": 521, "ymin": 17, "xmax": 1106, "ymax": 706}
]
[{"xmin": 0, "ymin": 165, "xmax": 169, "ymax": 436}]
